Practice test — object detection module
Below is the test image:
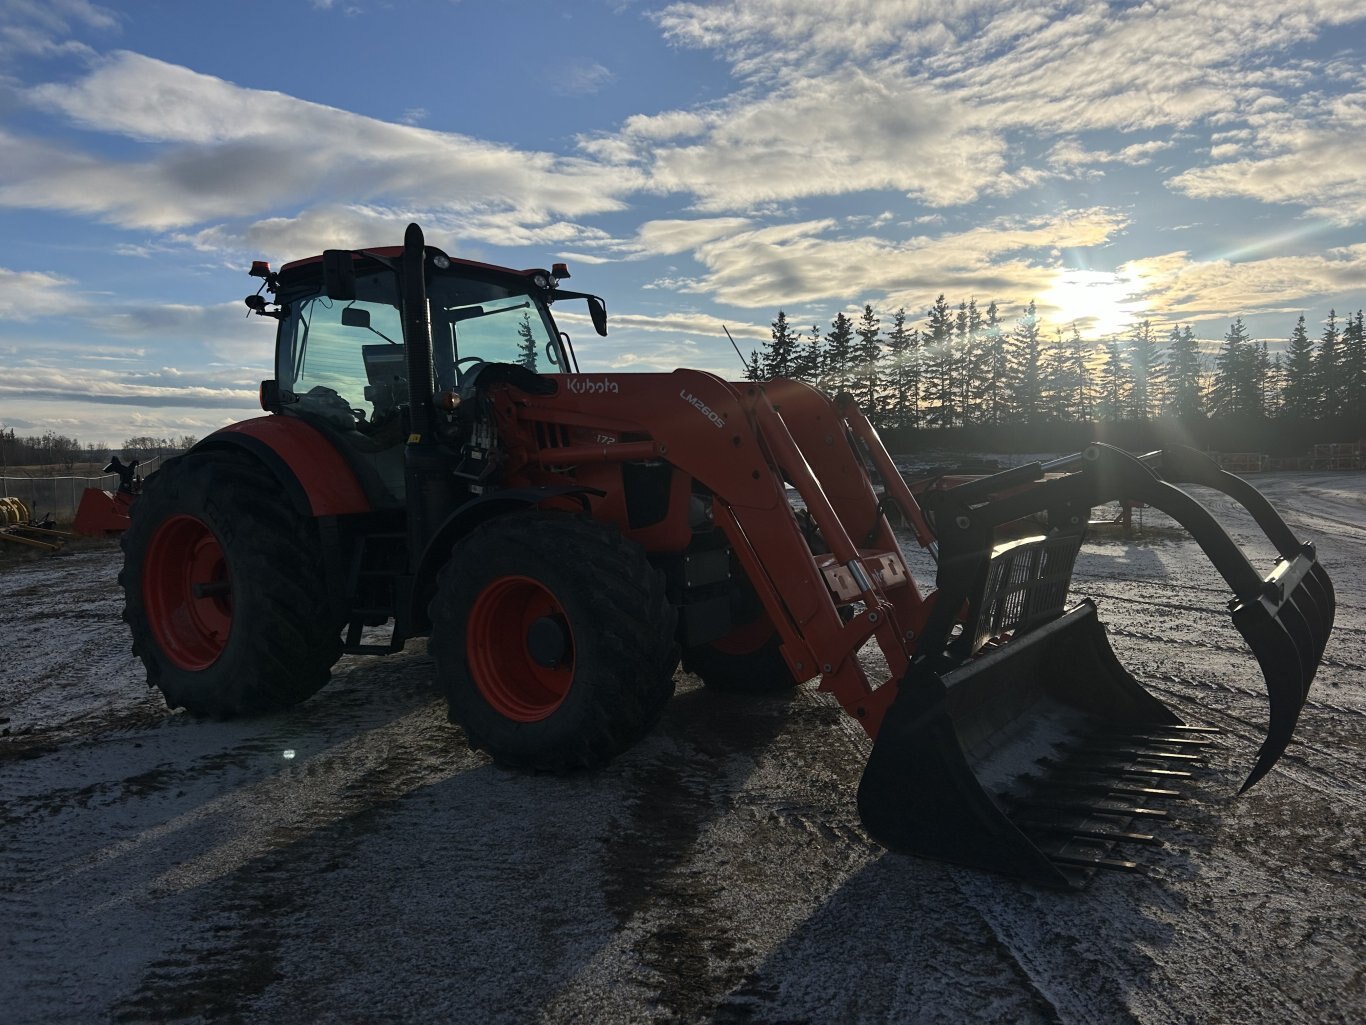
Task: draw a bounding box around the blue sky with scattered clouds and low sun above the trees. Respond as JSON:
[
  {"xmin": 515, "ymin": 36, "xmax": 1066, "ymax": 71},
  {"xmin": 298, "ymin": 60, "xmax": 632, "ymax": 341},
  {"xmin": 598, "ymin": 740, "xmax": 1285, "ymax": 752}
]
[{"xmin": 0, "ymin": 0, "xmax": 1366, "ymax": 446}]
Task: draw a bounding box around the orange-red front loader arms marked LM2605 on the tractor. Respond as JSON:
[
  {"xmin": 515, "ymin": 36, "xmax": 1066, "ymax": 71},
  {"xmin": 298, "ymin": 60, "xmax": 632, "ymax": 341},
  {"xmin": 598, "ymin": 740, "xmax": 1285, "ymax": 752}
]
[{"xmin": 493, "ymin": 370, "xmax": 928, "ymax": 737}]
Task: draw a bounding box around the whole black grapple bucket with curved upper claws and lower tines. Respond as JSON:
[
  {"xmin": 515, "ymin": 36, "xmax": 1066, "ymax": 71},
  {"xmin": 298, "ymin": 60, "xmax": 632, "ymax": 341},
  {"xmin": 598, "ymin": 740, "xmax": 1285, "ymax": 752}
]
[{"xmin": 858, "ymin": 444, "xmax": 1335, "ymax": 886}]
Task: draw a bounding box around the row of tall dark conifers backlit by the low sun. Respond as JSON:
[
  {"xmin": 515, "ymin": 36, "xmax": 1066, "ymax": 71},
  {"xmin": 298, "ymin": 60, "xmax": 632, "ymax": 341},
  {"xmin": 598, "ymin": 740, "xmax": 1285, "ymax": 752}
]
[{"xmin": 747, "ymin": 294, "xmax": 1366, "ymax": 442}]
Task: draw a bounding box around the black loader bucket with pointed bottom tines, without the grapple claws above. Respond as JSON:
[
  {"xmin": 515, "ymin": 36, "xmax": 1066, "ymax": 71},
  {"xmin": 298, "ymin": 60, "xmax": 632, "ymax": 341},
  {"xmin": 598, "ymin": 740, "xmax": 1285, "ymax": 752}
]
[{"xmin": 858, "ymin": 601, "xmax": 1186, "ymax": 887}]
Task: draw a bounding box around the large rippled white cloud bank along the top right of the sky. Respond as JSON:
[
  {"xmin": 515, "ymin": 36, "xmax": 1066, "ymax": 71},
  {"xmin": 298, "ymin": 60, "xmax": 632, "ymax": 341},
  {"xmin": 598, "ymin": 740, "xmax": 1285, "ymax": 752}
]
[{"xmin": 644, "ymin": 0, "xmax": 1366, "ymax": 216}]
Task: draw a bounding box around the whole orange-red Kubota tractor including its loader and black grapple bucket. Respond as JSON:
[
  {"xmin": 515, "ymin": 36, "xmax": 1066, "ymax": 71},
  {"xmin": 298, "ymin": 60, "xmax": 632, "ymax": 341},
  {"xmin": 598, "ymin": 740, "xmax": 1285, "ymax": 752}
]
[{"xmin": 120, "ymin": 226, "xmax": 1333, "ymax": 886}]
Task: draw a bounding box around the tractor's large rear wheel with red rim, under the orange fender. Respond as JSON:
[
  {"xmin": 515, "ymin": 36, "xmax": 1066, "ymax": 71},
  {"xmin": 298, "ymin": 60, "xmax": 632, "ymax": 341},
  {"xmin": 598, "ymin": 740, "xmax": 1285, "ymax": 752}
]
[{"xmin": 119, "ymin": 451, "xmax": 342, "ymax": 718}]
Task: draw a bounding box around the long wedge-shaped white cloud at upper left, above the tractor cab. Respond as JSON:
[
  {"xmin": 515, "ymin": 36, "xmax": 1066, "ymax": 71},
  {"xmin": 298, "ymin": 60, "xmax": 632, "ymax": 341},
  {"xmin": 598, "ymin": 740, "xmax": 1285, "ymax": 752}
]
[{"xmin": 0, "ymin": 52, "xmax": 639, "ymax": 231}]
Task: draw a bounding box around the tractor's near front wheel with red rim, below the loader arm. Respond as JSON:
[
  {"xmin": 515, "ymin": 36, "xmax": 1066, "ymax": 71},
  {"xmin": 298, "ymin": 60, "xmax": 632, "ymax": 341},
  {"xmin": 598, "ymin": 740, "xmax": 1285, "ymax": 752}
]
[{"xmin": 428, "ymin": 510, "xmax": 678, "ymax": 772}]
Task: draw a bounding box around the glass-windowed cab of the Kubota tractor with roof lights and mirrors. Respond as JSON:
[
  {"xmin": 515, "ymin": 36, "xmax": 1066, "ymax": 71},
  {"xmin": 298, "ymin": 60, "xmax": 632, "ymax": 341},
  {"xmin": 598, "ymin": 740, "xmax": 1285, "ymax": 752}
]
[{"xmin": 247, "ymin": 247, "xmax": 587, "ymax": 504}]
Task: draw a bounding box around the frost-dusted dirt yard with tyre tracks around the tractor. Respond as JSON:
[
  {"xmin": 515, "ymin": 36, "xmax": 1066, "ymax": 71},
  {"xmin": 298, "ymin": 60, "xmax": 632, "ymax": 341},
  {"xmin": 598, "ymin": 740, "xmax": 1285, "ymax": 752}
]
[{"xmin": 0, "ymin": 474, "xmax": 1366, "ymax": 1025}]
